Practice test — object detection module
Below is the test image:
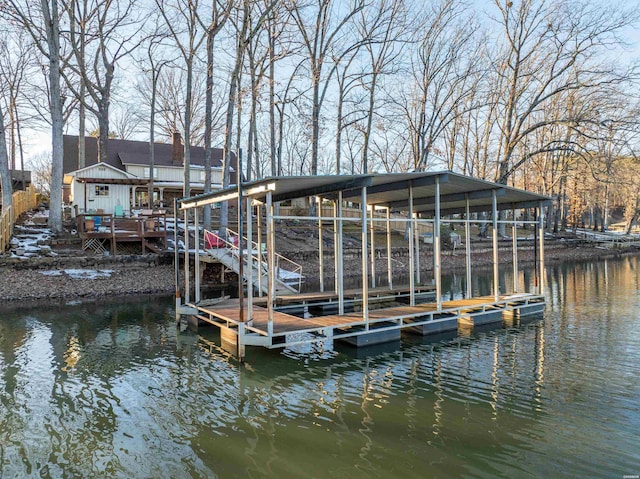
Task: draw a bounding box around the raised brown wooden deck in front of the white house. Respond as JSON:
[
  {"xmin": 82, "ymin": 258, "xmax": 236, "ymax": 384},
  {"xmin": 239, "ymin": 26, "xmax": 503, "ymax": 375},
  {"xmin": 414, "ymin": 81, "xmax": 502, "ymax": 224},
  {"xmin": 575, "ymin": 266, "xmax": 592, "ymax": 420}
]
[{"xmin": 76, "ymin": 213, "xmax": 167, "ymax": 255}]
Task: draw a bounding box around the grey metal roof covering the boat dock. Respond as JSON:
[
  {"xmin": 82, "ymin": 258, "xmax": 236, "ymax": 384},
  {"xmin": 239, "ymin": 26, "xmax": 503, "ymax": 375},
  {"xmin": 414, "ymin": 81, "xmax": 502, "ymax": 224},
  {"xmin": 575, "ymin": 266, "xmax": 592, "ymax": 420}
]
[{"xmin": 181, "ymin": 171, "xmax": 551, "ymax": 214}]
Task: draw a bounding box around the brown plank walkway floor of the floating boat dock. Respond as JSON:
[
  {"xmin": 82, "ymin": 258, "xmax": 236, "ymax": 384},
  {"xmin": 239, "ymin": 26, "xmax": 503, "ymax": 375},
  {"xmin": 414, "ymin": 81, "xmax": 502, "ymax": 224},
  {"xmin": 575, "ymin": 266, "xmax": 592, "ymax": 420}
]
[{"xmin": 192, "ymin": 294, "xmax": 544, "ymax": 347}]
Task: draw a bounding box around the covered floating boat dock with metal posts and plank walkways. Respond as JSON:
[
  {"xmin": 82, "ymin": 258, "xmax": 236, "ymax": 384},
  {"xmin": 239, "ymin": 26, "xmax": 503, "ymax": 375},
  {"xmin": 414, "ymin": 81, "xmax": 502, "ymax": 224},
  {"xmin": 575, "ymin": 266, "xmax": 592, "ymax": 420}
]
[{"xmin": 175, "ymin": 172, "xmax": 549, "ymax": 360}]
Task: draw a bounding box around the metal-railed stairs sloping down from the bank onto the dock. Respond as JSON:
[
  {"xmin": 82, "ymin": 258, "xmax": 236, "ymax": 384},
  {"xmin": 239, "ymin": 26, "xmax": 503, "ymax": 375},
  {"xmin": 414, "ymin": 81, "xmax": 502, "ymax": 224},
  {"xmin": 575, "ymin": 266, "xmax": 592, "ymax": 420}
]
[{"xmin": 204, "ymin": 229, "xmax": 303, "ymax": 295}]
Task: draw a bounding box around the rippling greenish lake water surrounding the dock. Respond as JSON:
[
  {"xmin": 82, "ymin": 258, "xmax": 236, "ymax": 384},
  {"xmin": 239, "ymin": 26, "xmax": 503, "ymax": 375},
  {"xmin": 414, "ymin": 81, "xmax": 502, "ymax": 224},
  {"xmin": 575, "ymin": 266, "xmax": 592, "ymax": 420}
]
[{"xmin": 0, "ymin": 258, "xmax": 640, "ymax": 478}]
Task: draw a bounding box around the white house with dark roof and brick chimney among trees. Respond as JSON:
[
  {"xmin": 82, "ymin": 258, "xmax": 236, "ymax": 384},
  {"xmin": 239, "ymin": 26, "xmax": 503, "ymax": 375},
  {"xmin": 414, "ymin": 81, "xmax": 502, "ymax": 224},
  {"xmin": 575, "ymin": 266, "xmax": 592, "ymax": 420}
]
[{"xmin": 63, "ymin": 132, "xmax": 235, "ymax": 214}]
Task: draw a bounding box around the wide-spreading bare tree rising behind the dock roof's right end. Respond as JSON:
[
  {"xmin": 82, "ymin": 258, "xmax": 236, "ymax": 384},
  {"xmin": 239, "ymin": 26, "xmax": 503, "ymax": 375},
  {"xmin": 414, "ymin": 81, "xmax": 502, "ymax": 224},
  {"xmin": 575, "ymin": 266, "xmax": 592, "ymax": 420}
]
[{"xmin": 495, "ymin": 0, "xmax": 637, "ymax": 183}]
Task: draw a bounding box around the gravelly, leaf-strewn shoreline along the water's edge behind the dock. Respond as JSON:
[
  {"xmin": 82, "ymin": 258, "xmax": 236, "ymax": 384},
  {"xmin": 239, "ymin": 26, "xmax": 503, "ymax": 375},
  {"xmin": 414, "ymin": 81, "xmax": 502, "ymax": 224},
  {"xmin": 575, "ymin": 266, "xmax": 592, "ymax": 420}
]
[{"xmin": 0, "ymin": 241, "xmax": 640, "ymax": 309}]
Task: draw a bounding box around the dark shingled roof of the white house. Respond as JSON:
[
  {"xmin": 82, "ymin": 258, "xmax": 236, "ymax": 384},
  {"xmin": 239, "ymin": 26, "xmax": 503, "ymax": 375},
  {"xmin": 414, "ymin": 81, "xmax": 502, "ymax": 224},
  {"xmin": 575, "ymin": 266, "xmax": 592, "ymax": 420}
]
[{"xmin": 63, "ymin": 135, "xmax": 235, "ymax": 173}]
